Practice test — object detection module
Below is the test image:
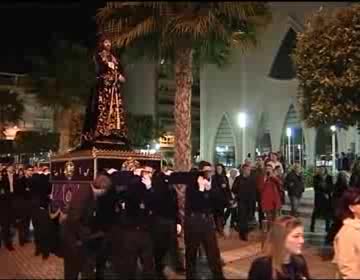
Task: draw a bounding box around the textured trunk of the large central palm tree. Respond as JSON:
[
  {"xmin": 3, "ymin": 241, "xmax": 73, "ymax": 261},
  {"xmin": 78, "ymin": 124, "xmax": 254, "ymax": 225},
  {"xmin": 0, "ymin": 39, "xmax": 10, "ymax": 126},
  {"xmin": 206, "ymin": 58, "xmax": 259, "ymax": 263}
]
[{"xmin": 174, "ymin": 48, "xmax": 193, "ymax": 228}]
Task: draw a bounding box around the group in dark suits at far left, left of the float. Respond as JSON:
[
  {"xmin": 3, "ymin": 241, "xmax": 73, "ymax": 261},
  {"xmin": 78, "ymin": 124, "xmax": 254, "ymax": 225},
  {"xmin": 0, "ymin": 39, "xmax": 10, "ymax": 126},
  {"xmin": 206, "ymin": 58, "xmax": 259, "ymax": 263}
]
[{"xmin": 0, "ymin": 165, "xmax": 51, "ymax": 259}]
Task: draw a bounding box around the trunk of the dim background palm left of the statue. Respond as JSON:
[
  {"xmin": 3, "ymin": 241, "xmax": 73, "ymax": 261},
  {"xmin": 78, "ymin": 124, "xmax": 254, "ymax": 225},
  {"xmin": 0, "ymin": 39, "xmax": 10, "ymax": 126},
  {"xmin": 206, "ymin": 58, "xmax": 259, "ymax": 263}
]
[{"xmin": 56, "ymin": 108, "xmax": 72, "ymax": 154}]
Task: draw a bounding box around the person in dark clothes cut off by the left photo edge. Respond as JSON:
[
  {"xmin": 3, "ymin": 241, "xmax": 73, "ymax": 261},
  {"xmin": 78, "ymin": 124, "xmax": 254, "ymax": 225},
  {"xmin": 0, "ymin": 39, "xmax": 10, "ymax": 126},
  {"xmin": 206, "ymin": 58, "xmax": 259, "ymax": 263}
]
[{"xmin": 0, "ymin": 169, "xmax": 14, "ymax": 251}]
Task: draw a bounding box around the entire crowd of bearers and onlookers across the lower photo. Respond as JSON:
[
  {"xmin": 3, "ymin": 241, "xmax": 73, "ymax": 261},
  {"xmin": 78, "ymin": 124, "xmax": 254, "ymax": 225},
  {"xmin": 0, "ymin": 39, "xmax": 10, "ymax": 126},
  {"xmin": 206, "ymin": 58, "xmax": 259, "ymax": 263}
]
[{"xmin": 0, "ymin": 153, "xmax": 360, "ymax": 279}]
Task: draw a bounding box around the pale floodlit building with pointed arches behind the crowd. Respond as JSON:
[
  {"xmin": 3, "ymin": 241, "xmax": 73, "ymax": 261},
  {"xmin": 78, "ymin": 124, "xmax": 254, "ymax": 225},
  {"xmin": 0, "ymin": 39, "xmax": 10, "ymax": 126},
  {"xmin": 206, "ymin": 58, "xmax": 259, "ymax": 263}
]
[{"xmin": 200, "ymin": 2, "xmax": 360, "ymax": 166}]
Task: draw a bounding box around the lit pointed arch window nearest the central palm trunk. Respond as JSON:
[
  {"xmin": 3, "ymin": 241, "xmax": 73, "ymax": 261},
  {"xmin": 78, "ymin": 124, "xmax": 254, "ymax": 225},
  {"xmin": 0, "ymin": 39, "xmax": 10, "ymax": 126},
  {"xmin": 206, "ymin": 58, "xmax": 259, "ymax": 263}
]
[{"xmin": 214, "ymin": 116, "xmax": 235, "ymax": 167}]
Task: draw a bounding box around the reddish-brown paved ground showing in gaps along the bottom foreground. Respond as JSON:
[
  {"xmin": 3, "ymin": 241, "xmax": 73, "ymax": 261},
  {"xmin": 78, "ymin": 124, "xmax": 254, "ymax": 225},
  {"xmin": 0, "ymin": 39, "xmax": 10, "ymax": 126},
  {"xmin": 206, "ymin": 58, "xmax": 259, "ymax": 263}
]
[{"xmin": 0, "ymin": 229, "xmax": 334, "ymax": 279}]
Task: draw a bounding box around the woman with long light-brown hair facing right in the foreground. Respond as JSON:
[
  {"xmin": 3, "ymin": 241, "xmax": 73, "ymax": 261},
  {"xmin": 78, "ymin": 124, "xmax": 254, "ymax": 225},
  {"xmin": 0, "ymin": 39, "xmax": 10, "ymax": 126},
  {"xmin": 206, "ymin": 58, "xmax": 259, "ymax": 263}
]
[{"xmin": 248, "ymin": 216, "xmax": 310, "ymax": 280}]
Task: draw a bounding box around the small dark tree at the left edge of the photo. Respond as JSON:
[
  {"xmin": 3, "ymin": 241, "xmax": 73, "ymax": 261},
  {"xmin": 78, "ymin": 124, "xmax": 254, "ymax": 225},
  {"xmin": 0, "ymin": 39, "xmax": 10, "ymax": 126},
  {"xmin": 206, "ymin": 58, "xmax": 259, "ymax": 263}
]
[{"xmin": 0, "ymin": 90, "xmax": 25, "ymax": 139}]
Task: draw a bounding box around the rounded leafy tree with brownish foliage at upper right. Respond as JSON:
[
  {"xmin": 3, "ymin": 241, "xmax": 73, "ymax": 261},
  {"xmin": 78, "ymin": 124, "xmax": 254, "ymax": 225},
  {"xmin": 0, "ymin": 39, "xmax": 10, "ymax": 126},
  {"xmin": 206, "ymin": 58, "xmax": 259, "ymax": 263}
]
[{"xmin": 293, "ymin": 5, "xmax": 360, "ymax": 127}]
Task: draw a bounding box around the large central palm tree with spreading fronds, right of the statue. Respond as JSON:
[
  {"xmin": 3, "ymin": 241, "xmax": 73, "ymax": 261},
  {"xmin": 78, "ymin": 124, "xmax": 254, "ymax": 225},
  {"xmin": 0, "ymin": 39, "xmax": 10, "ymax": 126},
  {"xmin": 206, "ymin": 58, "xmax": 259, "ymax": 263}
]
[{"xmin": 96, "ymin": 1, "xmax": 271, "ymax": 171}]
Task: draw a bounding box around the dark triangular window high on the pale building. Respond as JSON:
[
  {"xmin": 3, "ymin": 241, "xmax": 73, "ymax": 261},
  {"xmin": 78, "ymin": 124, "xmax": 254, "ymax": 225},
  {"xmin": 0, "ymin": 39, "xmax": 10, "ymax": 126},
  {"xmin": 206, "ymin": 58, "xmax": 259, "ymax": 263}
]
[{"xmin": 269, "ymin": 28, "xmax": 296, "ymax": 80}]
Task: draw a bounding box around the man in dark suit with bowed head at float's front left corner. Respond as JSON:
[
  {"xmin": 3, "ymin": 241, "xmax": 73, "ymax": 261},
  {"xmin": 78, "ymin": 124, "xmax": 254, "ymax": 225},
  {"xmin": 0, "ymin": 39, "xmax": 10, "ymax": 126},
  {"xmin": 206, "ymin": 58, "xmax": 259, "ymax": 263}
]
[{"xmin": 64, "ymin": 173, "xmax": 111, "ymax": 279}]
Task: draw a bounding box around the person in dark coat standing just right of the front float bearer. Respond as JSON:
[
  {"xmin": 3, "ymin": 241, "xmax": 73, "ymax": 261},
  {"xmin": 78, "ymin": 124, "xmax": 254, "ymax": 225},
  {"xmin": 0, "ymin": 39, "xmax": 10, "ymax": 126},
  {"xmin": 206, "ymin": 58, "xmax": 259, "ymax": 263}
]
[{"xmin": 211, "ymin": 164, "xmax": 231, "ymax": 236}]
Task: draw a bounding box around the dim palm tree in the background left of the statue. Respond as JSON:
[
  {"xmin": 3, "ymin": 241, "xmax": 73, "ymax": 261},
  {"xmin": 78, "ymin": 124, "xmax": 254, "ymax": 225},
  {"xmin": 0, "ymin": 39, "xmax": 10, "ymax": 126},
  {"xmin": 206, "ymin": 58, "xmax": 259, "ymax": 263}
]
[{"xmin": 29, "ymin": 40, "xmax": 95, "ymax": 153}]
